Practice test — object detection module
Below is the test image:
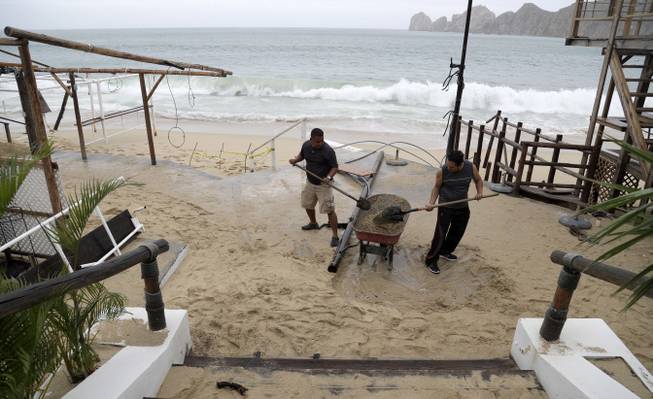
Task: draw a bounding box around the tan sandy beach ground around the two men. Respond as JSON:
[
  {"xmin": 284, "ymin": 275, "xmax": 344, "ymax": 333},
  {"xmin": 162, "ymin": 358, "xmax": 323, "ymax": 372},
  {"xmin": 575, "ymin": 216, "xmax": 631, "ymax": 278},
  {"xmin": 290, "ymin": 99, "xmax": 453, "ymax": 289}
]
[{"xmin": 3, "ymin": 120, "xmax": 653, "ymax": 397}]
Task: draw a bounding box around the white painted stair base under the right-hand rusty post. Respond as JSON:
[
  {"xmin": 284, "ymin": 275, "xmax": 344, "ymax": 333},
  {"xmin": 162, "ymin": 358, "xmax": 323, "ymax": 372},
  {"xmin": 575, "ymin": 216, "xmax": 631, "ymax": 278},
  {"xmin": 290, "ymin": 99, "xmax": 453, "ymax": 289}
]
[{"xmin": 510, "ymin": 319, "xmax": 653, "ymax": 399}]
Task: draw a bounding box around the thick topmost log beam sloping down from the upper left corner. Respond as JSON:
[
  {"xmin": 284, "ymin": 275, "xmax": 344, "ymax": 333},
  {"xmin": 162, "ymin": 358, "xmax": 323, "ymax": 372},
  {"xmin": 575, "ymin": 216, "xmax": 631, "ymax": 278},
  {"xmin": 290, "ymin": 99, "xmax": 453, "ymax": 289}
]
[{"xmin": 5, "ymin": 26, "xmax": 231, "ymax": 76}]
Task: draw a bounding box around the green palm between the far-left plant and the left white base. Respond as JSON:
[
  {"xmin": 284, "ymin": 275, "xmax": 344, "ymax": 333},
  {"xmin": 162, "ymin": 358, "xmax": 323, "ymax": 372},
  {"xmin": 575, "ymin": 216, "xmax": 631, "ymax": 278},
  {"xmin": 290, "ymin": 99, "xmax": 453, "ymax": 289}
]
[{"xmin": 49, "ymin": 180, "xmax": 126, "ymax": 382}]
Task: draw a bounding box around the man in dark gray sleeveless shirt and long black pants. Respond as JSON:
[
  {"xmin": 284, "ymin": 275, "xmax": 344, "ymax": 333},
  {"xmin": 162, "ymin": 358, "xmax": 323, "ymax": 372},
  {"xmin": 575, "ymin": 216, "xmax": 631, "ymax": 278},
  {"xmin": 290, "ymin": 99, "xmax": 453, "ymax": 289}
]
[{"xmin": 425, "ymin": 150, "xmax": 483, "ymax": 274}]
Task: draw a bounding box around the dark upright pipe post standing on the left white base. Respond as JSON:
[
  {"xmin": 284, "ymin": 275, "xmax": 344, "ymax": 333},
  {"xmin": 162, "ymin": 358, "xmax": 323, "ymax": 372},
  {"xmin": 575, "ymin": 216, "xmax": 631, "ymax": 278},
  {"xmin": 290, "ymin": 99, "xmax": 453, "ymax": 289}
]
[{"xmin": 141, "ymin": 242, "xmax": 166, "ymax": 331}]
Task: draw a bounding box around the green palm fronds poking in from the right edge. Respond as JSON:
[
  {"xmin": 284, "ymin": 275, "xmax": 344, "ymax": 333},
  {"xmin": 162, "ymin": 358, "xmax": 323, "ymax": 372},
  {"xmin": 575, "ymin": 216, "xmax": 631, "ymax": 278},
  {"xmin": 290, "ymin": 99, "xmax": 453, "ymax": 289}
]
[{"xmin": 582, "ymin": 142, "xmax": 653, "ymax": 309}]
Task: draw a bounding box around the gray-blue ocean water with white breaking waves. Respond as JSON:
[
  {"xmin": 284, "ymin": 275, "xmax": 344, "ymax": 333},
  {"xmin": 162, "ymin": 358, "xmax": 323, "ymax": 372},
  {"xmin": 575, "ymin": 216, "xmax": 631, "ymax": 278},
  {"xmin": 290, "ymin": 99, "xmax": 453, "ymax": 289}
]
[{"xmin": 0, "ymin": 28, "xmax": 602, "ymax": 141}]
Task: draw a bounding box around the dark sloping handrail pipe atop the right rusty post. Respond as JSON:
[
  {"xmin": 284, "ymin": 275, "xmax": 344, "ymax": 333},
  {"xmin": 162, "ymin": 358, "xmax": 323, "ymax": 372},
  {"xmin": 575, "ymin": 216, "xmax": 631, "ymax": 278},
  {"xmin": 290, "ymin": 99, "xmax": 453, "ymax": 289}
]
[{"xmin": 551, "ymin": 251, "xmax": 653, "ymax": 298}]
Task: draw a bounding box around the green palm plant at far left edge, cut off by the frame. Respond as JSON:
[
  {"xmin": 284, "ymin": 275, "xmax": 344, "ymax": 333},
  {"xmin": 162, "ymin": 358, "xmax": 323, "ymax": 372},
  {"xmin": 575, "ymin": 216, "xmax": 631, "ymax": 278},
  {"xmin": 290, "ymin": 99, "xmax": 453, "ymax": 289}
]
[{"xmin": 0, "ymin": 147, "xmax": 62, "ymax": 399}]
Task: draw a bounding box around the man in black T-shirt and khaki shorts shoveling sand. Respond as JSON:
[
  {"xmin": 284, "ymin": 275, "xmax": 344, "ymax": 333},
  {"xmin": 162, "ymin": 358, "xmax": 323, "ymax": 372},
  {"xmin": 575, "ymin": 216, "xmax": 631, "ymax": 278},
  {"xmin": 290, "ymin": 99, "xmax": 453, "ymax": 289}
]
[{"xmin": 289, "ymin": 128, "xmax": 339, "ymax": 247}]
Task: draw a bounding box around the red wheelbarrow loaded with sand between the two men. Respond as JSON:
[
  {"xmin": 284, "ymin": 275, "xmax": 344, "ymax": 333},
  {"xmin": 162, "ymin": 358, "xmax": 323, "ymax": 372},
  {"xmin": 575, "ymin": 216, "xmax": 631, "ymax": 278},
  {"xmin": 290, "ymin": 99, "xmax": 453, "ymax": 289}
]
[{"xmin": 354, "ymin": 194, "xmax": 410, "ymax": 270}]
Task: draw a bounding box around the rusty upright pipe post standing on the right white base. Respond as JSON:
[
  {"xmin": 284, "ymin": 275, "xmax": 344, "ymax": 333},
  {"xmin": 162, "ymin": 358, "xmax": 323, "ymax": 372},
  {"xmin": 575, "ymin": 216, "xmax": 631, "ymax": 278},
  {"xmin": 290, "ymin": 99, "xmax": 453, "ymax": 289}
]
[{"xmin": 540, "ymin": 253, "xmax": 580, "ymax": 342}]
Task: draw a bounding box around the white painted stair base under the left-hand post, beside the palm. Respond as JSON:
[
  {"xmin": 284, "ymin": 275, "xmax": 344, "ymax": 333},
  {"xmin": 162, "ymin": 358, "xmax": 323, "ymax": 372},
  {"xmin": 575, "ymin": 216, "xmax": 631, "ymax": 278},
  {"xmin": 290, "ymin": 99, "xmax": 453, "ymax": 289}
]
[{"xmin": 64, "ymin": 308, "xmax": 191, "ymax": 399}]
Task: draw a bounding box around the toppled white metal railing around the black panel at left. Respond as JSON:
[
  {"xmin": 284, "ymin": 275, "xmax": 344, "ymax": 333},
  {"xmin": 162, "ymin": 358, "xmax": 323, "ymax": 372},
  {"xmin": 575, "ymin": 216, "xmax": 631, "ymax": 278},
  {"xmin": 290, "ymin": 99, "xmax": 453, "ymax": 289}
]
[{"xmin": 0, "ymin": 176, "xmax": 144, "ymax": 272}]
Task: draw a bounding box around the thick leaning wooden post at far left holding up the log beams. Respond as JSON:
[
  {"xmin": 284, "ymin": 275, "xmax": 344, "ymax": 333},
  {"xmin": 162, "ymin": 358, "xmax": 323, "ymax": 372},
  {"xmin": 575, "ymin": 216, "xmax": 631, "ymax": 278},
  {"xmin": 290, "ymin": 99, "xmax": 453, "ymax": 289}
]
[{"xmin": 17, "ymin": 41, "xmax": 61, "ymax": 214}]
